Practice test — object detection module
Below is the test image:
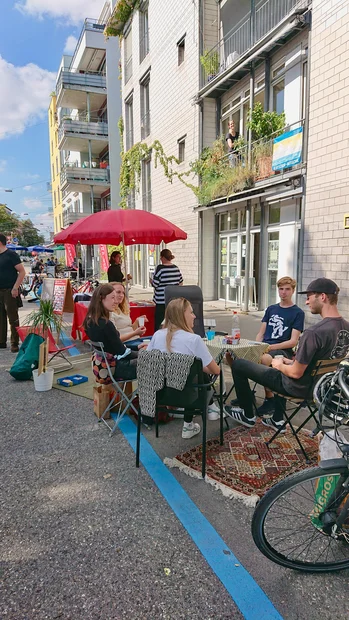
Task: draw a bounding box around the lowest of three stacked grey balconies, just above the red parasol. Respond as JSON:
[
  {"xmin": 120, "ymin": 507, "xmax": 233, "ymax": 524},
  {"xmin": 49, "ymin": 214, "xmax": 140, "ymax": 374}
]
[{"xmin": 61, "ymin": 164, "xmax": 110, "ymax": 196}]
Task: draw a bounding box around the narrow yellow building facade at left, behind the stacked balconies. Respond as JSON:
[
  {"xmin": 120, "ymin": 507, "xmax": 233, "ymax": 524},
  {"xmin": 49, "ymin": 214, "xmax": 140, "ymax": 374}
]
[{"xmin": 48, "ymin": 94, "xmax": 63, "ymax": 233}]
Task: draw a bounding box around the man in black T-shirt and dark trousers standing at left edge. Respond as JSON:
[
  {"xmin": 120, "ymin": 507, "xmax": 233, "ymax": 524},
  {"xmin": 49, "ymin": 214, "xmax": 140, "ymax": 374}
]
[{"xmin": 0, "ymin": 233, "xmax": 25, "ymax": 353}]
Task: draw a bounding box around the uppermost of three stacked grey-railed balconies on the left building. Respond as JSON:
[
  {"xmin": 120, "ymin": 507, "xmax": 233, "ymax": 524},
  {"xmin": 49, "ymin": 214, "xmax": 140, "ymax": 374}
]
[{"xmin": 56, "ymin": 69, "xmax": 107, "ymax": 110}]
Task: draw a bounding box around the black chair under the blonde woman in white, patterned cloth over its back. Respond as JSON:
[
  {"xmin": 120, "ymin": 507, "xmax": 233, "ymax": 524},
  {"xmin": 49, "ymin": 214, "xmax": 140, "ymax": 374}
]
[{"xmin": 136, "ymin": 351, "xmax": 223, "ymax": 478}]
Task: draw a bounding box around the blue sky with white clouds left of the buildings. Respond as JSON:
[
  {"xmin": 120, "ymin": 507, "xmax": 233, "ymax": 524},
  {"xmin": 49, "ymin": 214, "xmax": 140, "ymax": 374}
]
[{"xmin": 0, "ymin": 0, "xmax": 104, "ymax": 236}]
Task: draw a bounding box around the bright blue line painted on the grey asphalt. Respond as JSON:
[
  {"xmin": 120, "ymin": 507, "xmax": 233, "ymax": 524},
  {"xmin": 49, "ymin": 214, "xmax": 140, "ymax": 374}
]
[{"xmin": 119, "ymin": 416, "xmax": 283, "ymax": 620}]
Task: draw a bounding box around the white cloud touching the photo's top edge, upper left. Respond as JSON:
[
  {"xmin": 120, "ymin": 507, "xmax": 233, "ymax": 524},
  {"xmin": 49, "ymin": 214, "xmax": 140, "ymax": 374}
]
[{"xmin": 15, "ymin": 0, "xmax": 105, "ymax": 24}]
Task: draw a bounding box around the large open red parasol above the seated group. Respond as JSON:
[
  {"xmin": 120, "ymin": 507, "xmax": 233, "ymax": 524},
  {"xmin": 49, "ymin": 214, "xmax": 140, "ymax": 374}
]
[{"xmin": 54, "ymin": 209, "xmax": 187, "ymax": 245}]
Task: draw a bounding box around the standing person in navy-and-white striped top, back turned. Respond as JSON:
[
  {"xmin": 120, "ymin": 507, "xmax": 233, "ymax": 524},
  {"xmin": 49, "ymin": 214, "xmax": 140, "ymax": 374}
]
[{"xmin": 151, "ymin": 248, "xmax": 183, "ymax": 331}]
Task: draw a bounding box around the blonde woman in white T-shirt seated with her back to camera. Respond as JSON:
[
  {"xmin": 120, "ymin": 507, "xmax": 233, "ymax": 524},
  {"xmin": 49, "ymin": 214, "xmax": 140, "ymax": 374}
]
[{"xmin": 148, "ymin": 297, "xmax": 219, "ymax": 439}]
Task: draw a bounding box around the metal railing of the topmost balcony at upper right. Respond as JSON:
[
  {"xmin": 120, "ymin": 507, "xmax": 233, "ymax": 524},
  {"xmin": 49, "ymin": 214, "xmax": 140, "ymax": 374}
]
[{"xmin": 204, "ymin": 0, "xmax": 310, "ymax": 83}]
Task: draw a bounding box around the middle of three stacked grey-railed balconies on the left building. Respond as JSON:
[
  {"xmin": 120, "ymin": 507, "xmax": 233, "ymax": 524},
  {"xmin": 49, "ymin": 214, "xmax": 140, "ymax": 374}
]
[{"xmin": 58, "ymin": 115, "xmax": 108, "ymax": 155}]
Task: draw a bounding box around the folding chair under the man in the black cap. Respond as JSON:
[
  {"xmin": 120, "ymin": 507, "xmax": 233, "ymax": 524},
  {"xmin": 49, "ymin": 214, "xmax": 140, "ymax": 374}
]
[{"xmin": 266, "ymin": 357, "xmax": 344, "ymax": 463}]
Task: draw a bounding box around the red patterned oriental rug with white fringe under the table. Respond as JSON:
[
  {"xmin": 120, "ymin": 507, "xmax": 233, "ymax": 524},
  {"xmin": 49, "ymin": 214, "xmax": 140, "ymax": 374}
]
[{"xmin": 164, "ymin": 421, "xmax": 319, "ymax": 506}]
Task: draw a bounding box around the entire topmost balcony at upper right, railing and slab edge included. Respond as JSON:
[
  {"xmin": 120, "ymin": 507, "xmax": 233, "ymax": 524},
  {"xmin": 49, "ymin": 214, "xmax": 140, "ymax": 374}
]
[{"xmin": 201, "ymin": 0, "xmax": 310, "ymax": 97}]
